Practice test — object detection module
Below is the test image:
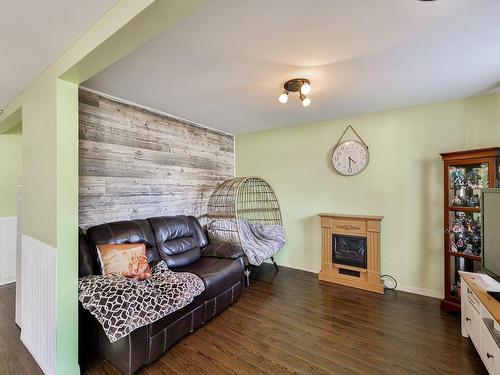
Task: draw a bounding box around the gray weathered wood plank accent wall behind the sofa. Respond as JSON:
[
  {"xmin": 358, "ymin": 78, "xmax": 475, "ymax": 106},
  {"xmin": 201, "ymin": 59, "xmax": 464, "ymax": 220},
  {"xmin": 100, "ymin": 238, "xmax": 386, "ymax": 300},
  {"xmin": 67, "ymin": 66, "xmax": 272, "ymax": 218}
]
[{"xmin": 79, "ymin": 89, "xmax": 234, "ymax": 229}]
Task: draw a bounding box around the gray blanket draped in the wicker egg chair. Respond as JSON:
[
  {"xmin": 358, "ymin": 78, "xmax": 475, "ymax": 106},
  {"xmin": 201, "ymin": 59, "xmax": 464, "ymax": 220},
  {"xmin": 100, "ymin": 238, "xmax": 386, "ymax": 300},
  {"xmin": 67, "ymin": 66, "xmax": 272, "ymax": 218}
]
[{"xmin": 239, "ymin": 220, "xmax": 285, "ymax": 266}]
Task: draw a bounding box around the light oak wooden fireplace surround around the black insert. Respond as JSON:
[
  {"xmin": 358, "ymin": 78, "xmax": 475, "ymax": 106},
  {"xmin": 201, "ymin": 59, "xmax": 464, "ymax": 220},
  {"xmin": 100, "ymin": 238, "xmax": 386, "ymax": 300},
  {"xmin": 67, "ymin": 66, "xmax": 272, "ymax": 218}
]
[{"xmin": 319, "ymin": 213, "xmax": 384, "ymax": 293}]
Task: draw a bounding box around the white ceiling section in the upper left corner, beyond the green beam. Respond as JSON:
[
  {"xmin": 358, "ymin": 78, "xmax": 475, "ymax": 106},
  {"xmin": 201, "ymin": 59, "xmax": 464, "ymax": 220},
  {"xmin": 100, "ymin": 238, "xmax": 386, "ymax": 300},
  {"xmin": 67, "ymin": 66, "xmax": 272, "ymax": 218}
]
[{"xmin": 0, "ymin": 0, "xmax": 116, "ymax": 108}]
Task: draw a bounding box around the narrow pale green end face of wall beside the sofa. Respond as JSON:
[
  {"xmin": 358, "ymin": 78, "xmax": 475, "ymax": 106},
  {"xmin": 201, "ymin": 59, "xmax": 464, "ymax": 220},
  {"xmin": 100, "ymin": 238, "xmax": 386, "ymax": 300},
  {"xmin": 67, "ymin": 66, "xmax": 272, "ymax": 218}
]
[{"xmin": 56, "ymin": 79, "xmax": 80, "ymax": 375}]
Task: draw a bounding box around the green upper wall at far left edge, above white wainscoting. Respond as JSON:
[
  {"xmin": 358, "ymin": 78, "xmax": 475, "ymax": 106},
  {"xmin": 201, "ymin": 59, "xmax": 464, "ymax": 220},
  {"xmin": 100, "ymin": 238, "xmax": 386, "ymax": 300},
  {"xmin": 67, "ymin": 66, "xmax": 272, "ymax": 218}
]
[{"xmin": 0, "ymin": 124, "xmax": 23, "ymax": 217}]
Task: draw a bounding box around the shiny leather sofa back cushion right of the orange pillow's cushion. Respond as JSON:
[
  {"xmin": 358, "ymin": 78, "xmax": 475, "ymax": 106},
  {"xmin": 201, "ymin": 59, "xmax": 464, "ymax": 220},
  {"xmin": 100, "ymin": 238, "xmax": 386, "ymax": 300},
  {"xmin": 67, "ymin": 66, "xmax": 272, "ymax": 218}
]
[{"xmin": 148, "ymin": 215, "xmax": 201, "ymax": 268}]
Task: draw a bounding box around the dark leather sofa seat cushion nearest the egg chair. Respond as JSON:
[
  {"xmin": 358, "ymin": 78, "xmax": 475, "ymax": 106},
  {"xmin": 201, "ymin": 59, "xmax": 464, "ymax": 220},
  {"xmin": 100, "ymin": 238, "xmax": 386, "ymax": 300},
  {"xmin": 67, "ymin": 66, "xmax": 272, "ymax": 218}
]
[{"xmin": 175, "ymin": 257, "xmax": 243, "ymax": 300}]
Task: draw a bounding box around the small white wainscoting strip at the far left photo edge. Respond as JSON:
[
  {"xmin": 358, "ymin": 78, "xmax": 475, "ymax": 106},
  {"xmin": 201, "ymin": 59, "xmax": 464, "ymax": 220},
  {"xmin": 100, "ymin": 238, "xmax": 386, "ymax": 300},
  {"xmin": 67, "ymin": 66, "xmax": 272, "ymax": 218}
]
[{"xmin": 0, "ymin": 216, "xmax": 17, "ymax": 285}]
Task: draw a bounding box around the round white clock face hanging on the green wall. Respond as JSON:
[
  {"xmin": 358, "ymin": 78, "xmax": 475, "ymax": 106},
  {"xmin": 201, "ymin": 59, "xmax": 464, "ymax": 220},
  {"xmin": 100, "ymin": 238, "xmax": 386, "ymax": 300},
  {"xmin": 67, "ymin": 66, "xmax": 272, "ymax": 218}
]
[{"xmin": 332, "ymin": 141, "xmax": 369, "ymax": 176}]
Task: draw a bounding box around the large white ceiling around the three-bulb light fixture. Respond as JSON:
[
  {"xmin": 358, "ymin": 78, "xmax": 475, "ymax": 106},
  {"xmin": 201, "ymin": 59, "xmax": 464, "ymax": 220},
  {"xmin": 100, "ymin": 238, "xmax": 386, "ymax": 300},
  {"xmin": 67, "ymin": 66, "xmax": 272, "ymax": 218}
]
[{"xmin": 84, "ymin": 0, "xmax": 500, "ymax": 134}]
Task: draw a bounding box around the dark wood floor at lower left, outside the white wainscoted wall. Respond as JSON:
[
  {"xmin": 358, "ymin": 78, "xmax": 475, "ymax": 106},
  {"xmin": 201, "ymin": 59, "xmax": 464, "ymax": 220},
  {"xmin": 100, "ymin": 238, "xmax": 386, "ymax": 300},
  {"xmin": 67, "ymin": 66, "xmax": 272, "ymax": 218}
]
[{"xmin": 0, "ymin": 284, "xmax": 43, "ymax": 375}]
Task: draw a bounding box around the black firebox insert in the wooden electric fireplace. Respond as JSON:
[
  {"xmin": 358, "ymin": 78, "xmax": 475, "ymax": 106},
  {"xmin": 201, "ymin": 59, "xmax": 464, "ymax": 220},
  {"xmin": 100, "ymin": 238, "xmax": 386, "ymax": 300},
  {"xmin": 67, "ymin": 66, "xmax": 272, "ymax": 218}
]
[{"xmin": 332, "ymin": 234, "xmax": 367, "ymax": 269}]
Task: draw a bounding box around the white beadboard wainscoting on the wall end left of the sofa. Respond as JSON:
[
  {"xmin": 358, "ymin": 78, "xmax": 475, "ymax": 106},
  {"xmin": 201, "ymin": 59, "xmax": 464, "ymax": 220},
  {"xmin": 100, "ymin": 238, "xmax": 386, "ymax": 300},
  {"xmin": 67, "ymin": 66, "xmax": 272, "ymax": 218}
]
[{"xmin": 21, "ymin": 234, "xmax": 57, "ymax": 375}]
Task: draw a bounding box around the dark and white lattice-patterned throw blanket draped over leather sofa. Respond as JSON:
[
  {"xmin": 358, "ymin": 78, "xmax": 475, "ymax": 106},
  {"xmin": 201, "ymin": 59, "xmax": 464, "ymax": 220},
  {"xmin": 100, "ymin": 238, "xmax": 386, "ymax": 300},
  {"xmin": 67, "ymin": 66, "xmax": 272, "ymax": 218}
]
[{"xmin": 78, "ymin": 261, "xmax": 205, "ymax": 342}]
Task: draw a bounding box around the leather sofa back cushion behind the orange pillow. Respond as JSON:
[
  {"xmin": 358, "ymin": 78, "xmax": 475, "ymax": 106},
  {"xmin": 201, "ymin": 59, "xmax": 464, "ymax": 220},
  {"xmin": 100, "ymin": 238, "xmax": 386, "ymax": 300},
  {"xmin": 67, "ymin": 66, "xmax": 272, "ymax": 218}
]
[{"xmin": 87, "ymin": 220, "xmax": 160, "ymax": 265}]
